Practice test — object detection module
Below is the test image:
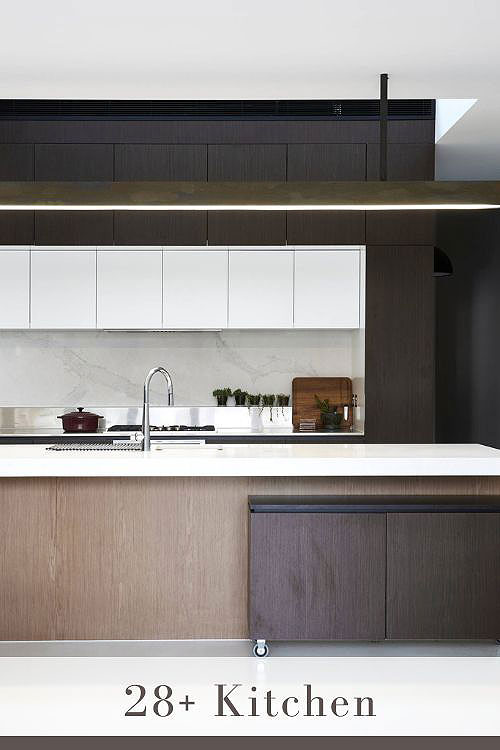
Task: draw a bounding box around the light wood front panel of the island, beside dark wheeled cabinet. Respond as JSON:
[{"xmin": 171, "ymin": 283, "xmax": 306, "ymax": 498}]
[{"xmin": 0, "ymin": 477, "xmax": 500, "ymax": 640}]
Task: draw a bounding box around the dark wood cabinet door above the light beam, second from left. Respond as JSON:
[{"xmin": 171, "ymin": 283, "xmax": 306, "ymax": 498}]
[{"xmin": 35, "ymin": 143, "xmax": 113, "ymax": 181}]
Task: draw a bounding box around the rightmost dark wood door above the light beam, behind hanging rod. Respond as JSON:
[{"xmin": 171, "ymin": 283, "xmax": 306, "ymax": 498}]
[{"xmin": 366, "ymin": 143, "xmax": 434, "ymax": 180}]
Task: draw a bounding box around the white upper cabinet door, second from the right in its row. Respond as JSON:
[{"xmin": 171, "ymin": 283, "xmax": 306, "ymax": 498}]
[{"xmin": 229, "ymin": 250, "xmax": 293, "ymax": 328}]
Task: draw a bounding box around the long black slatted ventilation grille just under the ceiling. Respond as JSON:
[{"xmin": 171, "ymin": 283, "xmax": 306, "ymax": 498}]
[{"xmin": 0, "ymin": 99, "xmax": 435, "ymax": 120}]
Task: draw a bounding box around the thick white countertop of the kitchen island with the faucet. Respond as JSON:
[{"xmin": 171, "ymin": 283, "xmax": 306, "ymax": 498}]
[{"xmin": 0, "ymin": 443, "xmax": 500, "ymax": 477}]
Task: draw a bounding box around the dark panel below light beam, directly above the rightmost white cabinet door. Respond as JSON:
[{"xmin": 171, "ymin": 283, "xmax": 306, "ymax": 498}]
[{"xmin": 287, "ymin": 211, "xmax": 365, "ymax": 245}]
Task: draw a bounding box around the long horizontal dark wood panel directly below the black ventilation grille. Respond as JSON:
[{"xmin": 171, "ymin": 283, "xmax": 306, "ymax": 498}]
[{"xmin": 0, "ymin": 120, "xmax": 434, "ymax": 144}]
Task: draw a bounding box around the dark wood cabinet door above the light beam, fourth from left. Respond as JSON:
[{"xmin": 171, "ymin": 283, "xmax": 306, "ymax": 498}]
[{"xmin": 208, "ymin": 144, "xmax": 286, "ymax": 182}]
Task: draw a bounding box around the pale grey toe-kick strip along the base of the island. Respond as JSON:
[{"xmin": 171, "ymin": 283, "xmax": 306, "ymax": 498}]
[{"xmin": 0, "ymin": 640, "xmax": 500, "ymax": 658}]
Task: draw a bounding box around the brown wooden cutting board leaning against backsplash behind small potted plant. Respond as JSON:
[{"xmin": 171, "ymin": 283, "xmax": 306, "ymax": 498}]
[{"xmin": 292, "ymin": 378, "xmax": 352, "ymax": 430}]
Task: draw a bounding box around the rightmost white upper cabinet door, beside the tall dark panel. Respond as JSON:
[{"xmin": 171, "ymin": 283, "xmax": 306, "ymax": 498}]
[{"xmin": 294, "ymin": 250, "xmax": 360, "ymax": 328}]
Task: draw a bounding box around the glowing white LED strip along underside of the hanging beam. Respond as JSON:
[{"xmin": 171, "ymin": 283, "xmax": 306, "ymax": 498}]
[{"xmin": 0, "ymin": 203, "xmax": 500, "ymax": 211}]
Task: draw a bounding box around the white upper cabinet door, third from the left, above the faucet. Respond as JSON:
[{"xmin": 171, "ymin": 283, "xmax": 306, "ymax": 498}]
[{"xmin": 97, "ymin": 248, "xmax": 162, "ymax": 329}]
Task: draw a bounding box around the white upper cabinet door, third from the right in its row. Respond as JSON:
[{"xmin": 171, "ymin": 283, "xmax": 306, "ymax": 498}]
[{"xmin": 163, "ymin": 250, "xmax": 228, "ymax": 328}]
